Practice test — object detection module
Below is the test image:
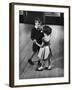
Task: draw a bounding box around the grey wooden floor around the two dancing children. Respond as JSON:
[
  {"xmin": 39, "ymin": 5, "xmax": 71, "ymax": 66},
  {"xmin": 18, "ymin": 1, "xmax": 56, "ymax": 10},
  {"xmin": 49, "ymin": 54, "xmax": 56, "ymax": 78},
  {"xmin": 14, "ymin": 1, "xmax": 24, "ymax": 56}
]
[{"xmin": 19, "ymin": 24, "xmax": 64, "ymax": 79}]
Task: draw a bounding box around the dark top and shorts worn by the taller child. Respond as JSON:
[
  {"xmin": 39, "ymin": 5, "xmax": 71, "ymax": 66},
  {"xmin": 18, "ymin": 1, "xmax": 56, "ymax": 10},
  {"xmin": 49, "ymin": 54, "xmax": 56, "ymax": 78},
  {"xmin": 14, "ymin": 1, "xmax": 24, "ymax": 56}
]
[{"xmin": 31, "ymin": 28, "xmax": 44, "ymax": 52}]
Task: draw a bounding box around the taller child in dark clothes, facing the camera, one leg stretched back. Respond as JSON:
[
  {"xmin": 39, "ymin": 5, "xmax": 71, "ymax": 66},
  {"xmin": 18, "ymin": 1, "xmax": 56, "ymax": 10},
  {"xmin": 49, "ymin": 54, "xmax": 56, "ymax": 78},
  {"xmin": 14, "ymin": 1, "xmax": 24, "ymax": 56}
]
[{"xmin": 28, "ymin": 18, "xmax": 44, "ymax": 65}]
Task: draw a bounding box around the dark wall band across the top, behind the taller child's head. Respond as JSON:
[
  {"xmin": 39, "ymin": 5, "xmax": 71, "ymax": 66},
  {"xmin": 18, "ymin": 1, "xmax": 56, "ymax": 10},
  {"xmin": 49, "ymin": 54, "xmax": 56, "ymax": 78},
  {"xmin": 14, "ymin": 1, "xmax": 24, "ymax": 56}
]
[{"xmin": 19, "ymin": 11, "xmax": 64, "ymax": 25}]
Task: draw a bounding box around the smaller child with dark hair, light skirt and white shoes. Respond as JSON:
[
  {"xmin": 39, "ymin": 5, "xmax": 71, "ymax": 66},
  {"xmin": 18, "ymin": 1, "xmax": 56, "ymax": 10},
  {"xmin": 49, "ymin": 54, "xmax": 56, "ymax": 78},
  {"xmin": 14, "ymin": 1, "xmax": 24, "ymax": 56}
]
[{"xmin": 37, "ymin": 26, "xmax": 52, "ymax": 71}]
